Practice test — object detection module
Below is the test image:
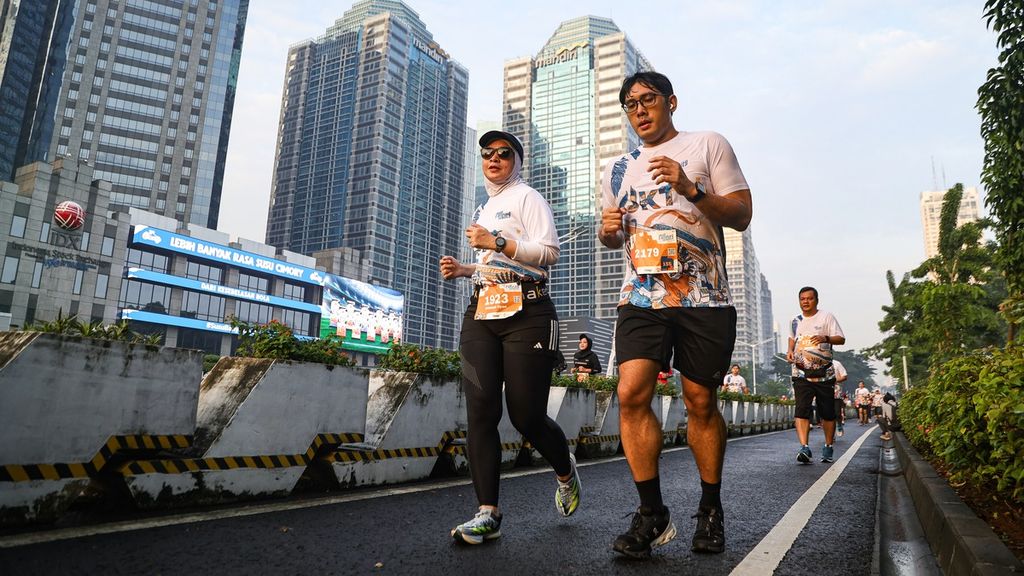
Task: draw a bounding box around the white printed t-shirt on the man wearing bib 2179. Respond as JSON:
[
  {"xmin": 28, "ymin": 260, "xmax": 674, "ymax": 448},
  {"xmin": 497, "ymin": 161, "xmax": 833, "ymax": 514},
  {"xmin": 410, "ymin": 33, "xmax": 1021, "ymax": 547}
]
[{"xmin": 601, "ymin": 132, "xmax": 750, "ymax": 308}]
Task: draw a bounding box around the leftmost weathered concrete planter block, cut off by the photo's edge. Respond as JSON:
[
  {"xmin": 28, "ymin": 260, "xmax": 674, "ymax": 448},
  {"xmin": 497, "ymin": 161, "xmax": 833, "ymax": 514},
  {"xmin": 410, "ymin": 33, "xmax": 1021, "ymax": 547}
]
[{"xmin": 0, "ymin": 332, "xmax": 203, "ymax": 524}]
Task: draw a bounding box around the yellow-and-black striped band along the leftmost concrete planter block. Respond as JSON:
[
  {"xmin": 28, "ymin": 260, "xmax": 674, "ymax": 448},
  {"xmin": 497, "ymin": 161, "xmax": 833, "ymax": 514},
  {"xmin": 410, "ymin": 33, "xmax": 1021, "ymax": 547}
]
[{"xmin": 0, "ymin": 435, "xmax": 193, "ymax": 482}]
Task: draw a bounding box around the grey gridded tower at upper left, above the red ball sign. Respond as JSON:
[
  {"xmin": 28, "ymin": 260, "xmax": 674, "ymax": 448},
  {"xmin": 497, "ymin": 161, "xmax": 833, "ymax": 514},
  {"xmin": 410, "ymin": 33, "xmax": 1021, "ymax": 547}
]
[{"xmin": 5, "ymin": 0, "xmax": 249, "ymax": 229}]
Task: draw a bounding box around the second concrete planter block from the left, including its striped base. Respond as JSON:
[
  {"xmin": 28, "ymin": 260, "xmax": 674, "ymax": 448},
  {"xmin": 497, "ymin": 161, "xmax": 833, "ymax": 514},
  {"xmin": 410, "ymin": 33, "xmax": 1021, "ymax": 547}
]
[{"xmin": 122, "ymin": 358, "xmax": 367, "ymax": 506}]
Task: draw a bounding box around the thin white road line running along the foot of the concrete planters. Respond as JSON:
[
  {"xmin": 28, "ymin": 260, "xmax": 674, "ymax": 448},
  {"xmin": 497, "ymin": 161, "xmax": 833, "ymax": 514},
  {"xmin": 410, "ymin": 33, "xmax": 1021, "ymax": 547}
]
[{"xmin": 0, "ymin": 430, "xmax": 770, "ymax": 548}]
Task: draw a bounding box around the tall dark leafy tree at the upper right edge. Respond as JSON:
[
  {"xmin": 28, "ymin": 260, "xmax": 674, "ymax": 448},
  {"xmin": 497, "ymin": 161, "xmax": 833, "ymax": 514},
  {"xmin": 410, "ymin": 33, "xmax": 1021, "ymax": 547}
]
[{"xmin": 977, "ymin": 0, "xmax": 1024, "ymax": 341}]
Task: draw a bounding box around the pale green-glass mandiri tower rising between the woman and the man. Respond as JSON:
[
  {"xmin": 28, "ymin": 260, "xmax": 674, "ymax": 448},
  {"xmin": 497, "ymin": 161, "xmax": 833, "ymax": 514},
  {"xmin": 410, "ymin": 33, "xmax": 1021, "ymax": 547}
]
[{"xmin": 503, "ymin": 16, "xmax": 651, "ymax": 318}]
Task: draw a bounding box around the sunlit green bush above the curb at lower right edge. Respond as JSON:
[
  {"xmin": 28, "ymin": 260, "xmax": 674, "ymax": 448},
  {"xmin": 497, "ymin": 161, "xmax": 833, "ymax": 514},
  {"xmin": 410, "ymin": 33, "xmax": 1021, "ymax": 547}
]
[{"xmin": 900, "ymin": 345, "xmax": 1024, "ymax": 503}]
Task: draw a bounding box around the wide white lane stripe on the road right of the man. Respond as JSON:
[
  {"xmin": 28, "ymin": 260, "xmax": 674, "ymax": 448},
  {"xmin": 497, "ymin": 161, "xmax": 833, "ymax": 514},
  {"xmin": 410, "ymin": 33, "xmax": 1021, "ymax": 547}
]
[{"xmin": 729, "ymin": 426, "xmax": 878, "ymax": 576}]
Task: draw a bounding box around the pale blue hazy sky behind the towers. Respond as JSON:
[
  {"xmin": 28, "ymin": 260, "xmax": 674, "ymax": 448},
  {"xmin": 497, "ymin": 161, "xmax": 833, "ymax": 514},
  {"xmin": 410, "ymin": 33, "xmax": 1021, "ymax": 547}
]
[{"xmin": 219, "ymin": 0, "xmax": 998, "ymax": 364}]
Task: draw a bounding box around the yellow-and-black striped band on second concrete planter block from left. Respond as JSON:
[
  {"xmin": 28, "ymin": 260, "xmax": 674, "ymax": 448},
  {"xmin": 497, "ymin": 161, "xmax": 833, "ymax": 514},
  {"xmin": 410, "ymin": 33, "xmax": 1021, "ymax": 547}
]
[{"xmin": 118, "ymin": 433, "xmax": 362, "ymax": 477}]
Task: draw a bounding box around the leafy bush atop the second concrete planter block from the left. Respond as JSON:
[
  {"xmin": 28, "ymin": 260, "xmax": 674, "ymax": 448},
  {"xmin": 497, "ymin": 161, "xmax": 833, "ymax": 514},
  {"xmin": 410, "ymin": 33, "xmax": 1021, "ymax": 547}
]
[{"xmin": 229, "ymin": 317, "xmax": 355, "ymax": 366}]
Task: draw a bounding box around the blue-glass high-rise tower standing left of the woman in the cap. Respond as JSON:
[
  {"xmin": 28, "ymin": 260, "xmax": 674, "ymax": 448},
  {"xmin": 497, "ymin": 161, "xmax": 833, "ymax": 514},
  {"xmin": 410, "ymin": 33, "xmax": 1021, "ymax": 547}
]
[{"xmin": 266, "ymin": 0, "xmax": 469, "ymax": 348}]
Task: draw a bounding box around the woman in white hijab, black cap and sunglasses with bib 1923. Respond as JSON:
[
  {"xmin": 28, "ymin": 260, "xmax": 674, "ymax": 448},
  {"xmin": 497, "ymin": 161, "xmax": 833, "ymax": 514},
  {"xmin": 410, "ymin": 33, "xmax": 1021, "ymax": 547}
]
[{"xmin": 440, "ymin": 130, "xmax": 580, "ymax": 544}]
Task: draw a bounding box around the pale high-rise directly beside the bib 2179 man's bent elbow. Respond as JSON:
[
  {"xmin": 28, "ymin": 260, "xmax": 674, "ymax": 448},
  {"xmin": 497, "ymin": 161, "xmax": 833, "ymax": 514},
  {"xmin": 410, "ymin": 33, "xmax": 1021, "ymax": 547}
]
[{"xmin": 724, "ymin": 228, "xmax": 774, "ymax": 365}]
